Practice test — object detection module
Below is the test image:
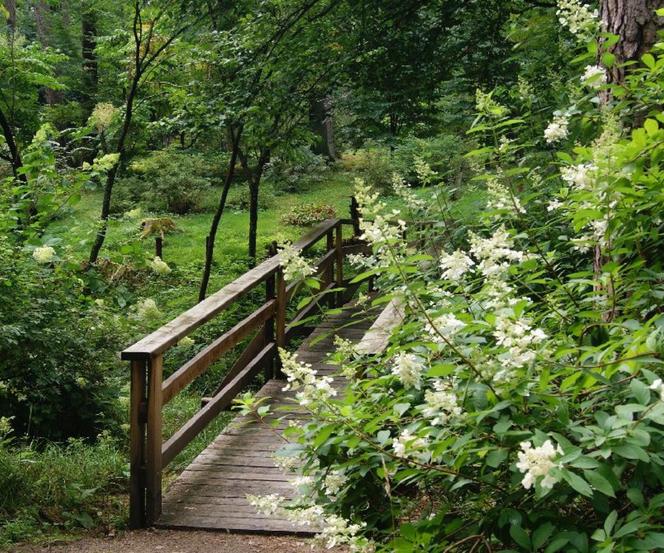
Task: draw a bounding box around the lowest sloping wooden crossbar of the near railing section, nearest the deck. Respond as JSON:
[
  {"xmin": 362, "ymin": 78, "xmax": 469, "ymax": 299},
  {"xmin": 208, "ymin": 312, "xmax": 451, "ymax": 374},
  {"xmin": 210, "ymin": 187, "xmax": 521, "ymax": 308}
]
[{"xmin": 162, "ymin": 344, "xmax": 275, "ymax": 466}]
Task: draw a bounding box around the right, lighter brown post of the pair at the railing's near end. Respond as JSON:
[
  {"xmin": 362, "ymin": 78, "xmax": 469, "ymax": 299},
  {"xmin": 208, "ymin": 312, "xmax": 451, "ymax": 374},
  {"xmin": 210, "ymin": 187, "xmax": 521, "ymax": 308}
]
[{"xmin": 145, "ymin": 354, "xmax": 163, "ymax": 526}]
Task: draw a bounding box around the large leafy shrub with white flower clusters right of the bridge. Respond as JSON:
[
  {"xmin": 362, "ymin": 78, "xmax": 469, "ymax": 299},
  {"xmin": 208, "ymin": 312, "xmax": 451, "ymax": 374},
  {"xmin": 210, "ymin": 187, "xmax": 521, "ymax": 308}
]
[{"xmin": 248, "ymin": 18, "xmax": 664, "ymax": 553}]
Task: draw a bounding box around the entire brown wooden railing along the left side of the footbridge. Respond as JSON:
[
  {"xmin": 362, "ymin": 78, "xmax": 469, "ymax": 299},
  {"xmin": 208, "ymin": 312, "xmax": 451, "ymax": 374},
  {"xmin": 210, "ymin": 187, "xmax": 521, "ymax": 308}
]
[{"xmin": 122, "ymin": 215, "xmax": 363, "ymax": 528}]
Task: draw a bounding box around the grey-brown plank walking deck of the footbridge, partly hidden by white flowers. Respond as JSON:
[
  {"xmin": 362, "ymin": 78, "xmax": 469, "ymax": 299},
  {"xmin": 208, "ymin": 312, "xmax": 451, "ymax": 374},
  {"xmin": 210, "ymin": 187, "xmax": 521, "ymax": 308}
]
[{"xmin": 157, "ymin": 300, "xmax": 377, "ymax": 534}]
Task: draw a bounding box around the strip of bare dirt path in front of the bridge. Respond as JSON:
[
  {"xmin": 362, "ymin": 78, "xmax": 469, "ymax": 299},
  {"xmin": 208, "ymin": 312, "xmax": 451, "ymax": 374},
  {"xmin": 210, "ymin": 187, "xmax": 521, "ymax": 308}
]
[{"xmin": 12, "ymin": 530, "xmax": 340, "ymax": 553}]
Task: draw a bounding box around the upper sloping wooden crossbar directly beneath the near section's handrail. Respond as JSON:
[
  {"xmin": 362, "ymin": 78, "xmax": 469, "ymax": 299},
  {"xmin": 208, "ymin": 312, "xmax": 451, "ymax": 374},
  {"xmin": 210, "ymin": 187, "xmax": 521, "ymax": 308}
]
[{"xmin": 162, "ymin": 300, "xmax": 276, "ymax": 404}]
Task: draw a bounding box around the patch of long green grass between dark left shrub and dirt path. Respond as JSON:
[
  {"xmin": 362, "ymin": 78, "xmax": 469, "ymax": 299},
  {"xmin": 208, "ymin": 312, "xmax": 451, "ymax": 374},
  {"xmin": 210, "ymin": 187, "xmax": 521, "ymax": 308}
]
[{"xmin": 0, "ymin": 435, "xmax": 127, "ymax": 547}]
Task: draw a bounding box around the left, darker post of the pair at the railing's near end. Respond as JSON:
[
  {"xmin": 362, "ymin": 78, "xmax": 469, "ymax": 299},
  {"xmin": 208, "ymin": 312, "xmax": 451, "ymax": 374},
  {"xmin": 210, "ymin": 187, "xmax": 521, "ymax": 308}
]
[{"xmin": 129, "ymin": 360, "xmax": 147, "ymax": 529}]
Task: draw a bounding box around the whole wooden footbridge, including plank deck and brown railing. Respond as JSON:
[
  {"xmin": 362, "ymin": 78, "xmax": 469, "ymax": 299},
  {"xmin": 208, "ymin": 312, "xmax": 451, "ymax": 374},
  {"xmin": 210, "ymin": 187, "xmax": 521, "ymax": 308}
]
[{"xmin": 122, "ymin": 211, "xmax": 390, "ymax": 532}]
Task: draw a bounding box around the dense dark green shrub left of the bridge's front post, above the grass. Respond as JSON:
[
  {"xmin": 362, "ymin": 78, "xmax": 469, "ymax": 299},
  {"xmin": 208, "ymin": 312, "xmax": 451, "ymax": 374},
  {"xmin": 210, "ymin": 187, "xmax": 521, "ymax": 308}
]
[{"xmin": 0, "ymin": 240, "xmax": 122, "ymax": 439}]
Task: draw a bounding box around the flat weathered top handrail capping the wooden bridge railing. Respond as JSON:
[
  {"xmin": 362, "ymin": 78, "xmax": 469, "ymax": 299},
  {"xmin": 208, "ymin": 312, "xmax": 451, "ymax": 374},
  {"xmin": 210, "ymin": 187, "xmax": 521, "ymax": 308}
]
[{"xmin": 122, "ymin": 219, "xmax": 339, "ymax": 360}]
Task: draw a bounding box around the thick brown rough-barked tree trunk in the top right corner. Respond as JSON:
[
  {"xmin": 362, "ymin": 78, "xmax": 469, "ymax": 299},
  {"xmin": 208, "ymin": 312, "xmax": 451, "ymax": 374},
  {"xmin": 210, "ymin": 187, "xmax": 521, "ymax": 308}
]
[{"xmin": 600, "ymin": 0, "xmax": 664, "ymax": 83}]
